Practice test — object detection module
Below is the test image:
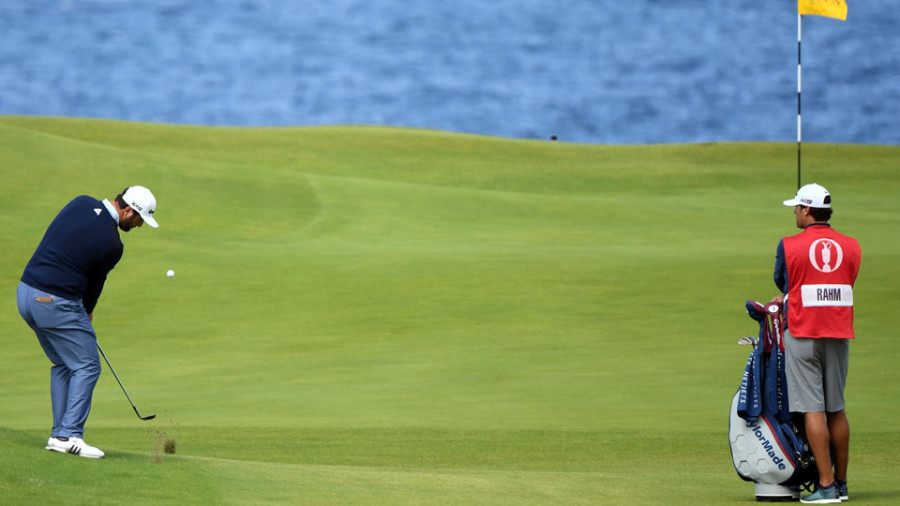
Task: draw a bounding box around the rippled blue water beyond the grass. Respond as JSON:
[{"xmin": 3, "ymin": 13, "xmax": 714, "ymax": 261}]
[{"xmin": 0, "ymin": 0, "xmax": 900, "ymax": 144}]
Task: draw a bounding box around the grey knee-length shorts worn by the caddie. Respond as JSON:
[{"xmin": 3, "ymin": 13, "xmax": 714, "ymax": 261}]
[{"xmin": 784, "ymin": 330, "xmax": 850, "ymax": 413}]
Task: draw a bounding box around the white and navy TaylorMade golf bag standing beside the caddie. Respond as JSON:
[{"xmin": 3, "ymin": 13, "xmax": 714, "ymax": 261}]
[{"xmin": 728, "ymin": 301, "xmax": 818, "ymax": 501}]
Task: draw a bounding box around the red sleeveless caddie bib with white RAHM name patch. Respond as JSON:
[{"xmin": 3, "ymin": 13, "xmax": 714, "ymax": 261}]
[{"xmin": 784, "ymin": 225, "xmax": 860, "ymax": 339}]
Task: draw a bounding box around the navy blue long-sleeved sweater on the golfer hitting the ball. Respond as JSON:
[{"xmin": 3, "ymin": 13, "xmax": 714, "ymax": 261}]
[{"xmin": 22, "ymin": 195, "xmax": 125, "ymax": 313}]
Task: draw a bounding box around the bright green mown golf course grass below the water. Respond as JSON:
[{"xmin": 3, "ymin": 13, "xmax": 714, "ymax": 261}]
[{"xmin": 0, "ymin": 116, "xmax": 900, "ymax": 505}]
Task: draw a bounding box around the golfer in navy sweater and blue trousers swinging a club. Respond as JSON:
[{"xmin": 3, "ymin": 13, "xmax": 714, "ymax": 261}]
[{"xmin": 17, "ymin": 186, "xmax": 159, "ymax": 459}]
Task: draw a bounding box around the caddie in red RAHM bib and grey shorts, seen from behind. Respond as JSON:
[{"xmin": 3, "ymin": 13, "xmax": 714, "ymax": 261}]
[{"xmin": 774, "ymin": 184, "xmax": 860, "ymax": 504}]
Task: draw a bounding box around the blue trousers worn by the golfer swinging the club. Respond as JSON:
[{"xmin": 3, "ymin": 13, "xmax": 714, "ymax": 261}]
[{"xmin": 17, "ymin": 282, "xmax": 100, "ymax": 438}]
